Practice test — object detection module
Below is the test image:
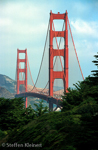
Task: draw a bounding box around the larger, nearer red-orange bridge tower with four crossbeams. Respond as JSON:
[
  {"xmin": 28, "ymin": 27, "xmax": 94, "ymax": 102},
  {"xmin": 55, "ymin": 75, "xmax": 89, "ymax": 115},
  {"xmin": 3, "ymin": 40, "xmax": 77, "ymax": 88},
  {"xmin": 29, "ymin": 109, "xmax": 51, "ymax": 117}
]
[{"xmin": 49, "ymin": 11, "xmax": 68, "ymax": 109}]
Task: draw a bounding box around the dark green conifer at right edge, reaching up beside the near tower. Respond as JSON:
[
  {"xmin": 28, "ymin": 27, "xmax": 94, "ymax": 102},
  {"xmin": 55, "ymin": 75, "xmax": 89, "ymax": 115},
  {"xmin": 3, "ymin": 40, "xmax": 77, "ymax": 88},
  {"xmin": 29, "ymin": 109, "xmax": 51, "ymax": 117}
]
[{"xmin": 61, "ymin": 52, "xmax": 98, "ymax": 111}]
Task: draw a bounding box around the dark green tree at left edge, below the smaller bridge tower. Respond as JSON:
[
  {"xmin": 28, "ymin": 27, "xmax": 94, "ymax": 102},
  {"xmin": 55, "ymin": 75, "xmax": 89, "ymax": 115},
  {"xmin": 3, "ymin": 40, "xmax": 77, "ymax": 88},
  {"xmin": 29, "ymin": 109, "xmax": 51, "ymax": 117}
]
[{"xmin": 0, "ymin": 98, "xmax": 34, "ymax": 130}]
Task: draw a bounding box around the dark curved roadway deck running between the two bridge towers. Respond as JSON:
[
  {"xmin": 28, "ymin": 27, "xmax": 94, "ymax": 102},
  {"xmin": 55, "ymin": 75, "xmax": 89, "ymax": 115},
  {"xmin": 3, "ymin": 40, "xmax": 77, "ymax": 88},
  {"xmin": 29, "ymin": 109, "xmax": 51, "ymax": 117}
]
[{"xmin": 15, "ymin": 92, "xmax": 62, "ymax": 106}]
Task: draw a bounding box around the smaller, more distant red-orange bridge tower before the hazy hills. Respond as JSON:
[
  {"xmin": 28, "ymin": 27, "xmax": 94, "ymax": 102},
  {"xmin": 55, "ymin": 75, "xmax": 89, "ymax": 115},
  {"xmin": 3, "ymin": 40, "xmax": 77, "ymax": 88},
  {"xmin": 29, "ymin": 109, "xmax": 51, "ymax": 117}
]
[{"xmin": 17, "ymin": 49, "xmax": 27, "ymax": 108}]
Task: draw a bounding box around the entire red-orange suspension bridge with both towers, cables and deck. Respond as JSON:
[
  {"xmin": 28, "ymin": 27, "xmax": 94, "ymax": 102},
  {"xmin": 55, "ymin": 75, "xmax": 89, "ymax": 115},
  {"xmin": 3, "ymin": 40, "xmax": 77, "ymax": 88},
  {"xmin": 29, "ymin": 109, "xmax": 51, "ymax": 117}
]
[{"xmin": 15, "ymin": 11, "xmax": 84, "ymax": 110}]
